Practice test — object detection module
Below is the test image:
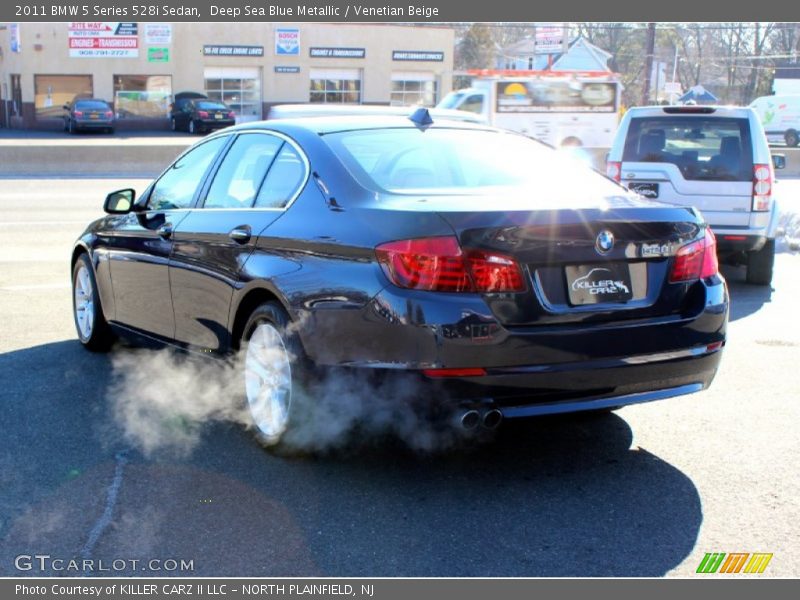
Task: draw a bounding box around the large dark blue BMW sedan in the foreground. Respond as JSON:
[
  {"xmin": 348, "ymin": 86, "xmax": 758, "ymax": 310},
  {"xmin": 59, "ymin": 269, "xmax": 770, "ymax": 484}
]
[{"xmin": 72, "ymin": 109, "xmax": 728, "ymax": 446}]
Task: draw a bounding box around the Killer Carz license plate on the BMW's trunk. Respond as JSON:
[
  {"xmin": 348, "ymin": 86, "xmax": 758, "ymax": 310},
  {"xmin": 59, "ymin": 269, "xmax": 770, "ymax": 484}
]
[{"xmin": 564, "ymin": 262, "xmax": 633, "ymax": 306}]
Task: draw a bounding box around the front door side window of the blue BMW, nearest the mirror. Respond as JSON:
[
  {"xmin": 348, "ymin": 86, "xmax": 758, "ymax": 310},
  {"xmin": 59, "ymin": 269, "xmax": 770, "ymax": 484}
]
[{"xmin": 147, "ymin": 136, "xmax": 228, "ymax": 210}]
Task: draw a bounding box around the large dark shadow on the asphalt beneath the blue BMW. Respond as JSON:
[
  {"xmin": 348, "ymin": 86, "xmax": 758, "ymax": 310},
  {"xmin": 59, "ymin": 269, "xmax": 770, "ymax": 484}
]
[{"xmin": 0, "ymin": 340, "xmax": 703, "ymax": 577}]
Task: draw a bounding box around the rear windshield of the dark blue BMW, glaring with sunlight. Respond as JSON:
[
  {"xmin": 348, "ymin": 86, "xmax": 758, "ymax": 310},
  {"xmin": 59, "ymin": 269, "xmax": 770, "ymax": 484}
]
[{"xmin": 323, "ymin": 128, "xmax": 620, "ymax": 198}]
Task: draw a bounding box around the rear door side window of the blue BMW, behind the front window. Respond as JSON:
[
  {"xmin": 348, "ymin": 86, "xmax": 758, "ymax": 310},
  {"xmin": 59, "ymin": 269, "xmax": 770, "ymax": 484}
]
[{"xmin": 203, "ymin": 133, "xmax": 283, "ymax": 208}]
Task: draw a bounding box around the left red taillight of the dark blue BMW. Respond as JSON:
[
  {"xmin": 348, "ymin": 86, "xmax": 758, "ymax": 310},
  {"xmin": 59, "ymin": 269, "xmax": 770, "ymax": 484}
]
[{"xmin": 375, "ymin": 236, "xmax": 525, "ymax": 293}]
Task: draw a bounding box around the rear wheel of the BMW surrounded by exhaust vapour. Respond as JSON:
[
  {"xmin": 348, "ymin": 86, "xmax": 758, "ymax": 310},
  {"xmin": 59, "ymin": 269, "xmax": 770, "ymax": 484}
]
[{"xmin": 240, "ymin": 302, "xmax": 311, "ymax": 455}]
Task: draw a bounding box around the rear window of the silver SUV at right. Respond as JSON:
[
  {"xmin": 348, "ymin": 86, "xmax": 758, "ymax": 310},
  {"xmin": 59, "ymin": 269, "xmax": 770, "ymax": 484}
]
[{"xmin": 622, "ymin": 116, "xmax": 753, "ymax": 181}]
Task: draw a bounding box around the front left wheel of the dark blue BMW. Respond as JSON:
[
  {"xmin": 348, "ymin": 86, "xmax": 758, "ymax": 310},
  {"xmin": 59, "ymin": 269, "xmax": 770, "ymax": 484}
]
[{"xmin": 72, "ymin": 254, "xmax": 114, "ymax": 352}]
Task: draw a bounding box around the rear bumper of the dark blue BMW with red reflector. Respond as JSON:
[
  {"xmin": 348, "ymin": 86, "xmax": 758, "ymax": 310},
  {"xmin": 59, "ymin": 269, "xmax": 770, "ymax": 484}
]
[{"xmin": 301, "ymin": 278, "xmax": 728, "ymax": 417}]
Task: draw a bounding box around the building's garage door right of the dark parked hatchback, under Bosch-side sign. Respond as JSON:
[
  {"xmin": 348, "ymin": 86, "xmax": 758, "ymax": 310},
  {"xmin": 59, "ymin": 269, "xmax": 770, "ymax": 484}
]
[{"xmin": 205, "ymin": 67, "xmax": 261, "ymax": 122}]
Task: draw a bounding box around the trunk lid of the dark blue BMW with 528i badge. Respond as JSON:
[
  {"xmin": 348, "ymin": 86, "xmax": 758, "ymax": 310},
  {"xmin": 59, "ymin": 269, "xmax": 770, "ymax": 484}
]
[{"xmin": 432, "ymin": 199, "xmax": 702, "ymax": 326}]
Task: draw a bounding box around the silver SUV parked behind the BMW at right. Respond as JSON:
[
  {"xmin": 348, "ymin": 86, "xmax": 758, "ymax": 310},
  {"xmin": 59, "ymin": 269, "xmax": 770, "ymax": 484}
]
[{"xmin": 607, "ymin": 106, "xmax": 785, "ymax": 285}]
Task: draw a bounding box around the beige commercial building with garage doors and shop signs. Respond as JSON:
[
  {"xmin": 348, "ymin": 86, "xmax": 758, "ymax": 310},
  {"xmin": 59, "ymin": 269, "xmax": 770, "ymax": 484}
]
[{"xmin": 0, "ymin": 22, "xmax": 454, "ymax": 129}]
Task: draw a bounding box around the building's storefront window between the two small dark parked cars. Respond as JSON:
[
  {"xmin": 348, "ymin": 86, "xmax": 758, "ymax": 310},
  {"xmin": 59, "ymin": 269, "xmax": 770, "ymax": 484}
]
[{"xmin": 114, "ymin": 75, "xmax": 172, "ymax": 119}]
